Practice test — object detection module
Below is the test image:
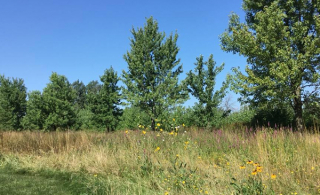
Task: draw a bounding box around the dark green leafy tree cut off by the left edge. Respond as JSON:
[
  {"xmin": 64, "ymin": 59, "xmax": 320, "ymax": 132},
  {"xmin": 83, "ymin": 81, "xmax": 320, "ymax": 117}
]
[{"xmin": 0, "ymin": 75, "xmax": 27, "ymax": 130}]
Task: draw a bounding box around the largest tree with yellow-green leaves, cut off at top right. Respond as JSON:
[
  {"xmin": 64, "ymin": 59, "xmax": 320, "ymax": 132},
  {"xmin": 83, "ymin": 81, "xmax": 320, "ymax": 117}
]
[{"xmin": 221, "ymin": 0, "xmax": 320, "ymax": 130}]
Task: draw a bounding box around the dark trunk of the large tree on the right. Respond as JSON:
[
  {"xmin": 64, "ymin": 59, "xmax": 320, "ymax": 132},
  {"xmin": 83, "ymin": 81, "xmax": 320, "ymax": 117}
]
[{"xmin": 293, "ymin": 87, "xmax": 303, "ymax": 131}]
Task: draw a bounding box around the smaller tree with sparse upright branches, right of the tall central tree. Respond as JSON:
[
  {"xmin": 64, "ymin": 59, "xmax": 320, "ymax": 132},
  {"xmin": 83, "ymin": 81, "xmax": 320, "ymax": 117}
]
[{"xmin": 186, "ymin": 55, "xmax": 228, "ymax": 127}]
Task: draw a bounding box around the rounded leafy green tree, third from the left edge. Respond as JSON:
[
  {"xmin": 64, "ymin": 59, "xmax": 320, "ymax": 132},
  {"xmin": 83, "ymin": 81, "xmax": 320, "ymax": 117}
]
[{"xmin": 43, "ymin": 72, "xmax": 75, "ymax": 130}]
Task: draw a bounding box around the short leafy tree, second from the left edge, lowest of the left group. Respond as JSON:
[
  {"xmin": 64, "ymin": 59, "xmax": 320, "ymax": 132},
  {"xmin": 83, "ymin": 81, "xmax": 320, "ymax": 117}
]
[{"xmin": 22, "ymin": 91, "xmax": 46, "ymax": 130}]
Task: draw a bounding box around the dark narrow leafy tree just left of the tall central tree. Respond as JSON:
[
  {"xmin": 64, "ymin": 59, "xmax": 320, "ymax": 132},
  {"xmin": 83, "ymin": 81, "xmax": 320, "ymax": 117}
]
[{"xmin": 89, "ymin": 67, "xmax": 122, "ymax": 131}]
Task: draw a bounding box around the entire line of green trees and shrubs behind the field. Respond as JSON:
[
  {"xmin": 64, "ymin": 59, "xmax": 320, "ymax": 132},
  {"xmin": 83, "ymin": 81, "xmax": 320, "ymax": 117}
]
[{"xmin": 0, "ymin": 0, "xmax": 320, "ymax": 131}]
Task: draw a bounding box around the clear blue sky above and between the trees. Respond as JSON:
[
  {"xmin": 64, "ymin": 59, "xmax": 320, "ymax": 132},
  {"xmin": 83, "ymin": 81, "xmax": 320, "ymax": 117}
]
[{"xmin": 0, "ymin": 0, "xmax": 246, "ymax": 107}]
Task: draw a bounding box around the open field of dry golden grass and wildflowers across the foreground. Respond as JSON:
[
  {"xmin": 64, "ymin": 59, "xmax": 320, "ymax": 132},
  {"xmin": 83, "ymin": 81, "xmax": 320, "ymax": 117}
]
[{"xmin": 0, "ymin": 129, "xmax": 320, "ymax": 194}]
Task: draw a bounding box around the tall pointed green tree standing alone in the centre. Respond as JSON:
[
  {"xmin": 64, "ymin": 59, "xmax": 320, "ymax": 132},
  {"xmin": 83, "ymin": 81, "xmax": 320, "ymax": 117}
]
[{"xmin": 123, "ymin": 17, "xmax": 188, "ymax": 130}]
